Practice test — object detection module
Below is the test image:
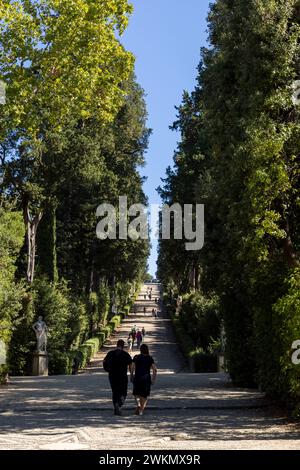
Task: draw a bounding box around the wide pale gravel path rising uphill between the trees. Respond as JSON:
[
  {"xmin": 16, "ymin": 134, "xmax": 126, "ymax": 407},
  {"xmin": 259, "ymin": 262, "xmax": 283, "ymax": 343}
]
[{"xmin": 0, "ymin": 284, "xmax": 300, "ymax": 450}]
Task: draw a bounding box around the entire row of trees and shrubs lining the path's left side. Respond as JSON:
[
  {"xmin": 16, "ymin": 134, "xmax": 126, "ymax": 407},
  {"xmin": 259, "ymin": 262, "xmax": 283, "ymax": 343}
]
[{"xmin": 0, "ymin": 0, "xmax": 149, "ymax": 375}]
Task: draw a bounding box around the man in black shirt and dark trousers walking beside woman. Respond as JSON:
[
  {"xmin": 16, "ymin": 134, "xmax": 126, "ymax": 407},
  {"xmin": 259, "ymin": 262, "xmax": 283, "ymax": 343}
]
[{"xmin": 103, "ymin": 339, "xmax": 132, "ymax": 415}]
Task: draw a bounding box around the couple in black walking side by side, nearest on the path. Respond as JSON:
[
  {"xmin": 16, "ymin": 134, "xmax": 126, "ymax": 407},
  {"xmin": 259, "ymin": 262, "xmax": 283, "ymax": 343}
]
[{"xmin": 103, "ymin": 339, "xmax": 157, "ymax": 415}]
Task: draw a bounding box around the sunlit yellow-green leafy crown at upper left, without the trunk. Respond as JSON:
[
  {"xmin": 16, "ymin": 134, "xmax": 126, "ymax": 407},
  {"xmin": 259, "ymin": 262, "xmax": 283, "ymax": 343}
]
[{"xmin": 0, "ymin": 0, "xmax": 133, "ymax": 135}]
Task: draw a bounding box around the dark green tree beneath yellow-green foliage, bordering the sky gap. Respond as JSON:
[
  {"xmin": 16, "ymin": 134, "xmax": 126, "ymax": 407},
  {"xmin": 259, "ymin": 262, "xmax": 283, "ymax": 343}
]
[{"xmin": 57, "ymin": 77, "xmax": 149, "ymax": 293}]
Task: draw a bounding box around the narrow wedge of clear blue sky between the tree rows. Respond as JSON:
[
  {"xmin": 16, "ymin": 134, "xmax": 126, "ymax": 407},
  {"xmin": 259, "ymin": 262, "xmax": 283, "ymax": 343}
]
[{"xmin": 122, "ymin": 0, "xmax": 211, "ymax": 275}]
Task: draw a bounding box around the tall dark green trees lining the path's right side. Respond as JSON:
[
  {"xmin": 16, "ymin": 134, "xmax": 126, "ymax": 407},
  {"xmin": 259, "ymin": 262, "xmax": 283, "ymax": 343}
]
[{"xmin": 158, "ymin": 0, "xmax": 300, "ymax": 414}]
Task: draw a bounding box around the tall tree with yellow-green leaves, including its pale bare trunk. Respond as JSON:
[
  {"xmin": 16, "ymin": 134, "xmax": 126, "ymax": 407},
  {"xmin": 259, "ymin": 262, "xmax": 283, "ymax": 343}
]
[{"xmin": 0, "ymin": 0, "xmax": 133, "ymax": 283}]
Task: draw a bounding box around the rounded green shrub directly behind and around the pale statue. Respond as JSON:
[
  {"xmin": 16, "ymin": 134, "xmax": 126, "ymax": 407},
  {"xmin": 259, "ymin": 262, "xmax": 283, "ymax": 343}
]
[{"xmin": 9, "ymin": 278, "xmax": 88, "ymax": 375}]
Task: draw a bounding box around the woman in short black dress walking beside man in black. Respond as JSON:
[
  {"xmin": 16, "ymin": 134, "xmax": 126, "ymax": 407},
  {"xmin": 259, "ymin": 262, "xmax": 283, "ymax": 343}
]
[{"xmin": 131, "ymin": 344, "xmax": 157, "ymax": 415}]
